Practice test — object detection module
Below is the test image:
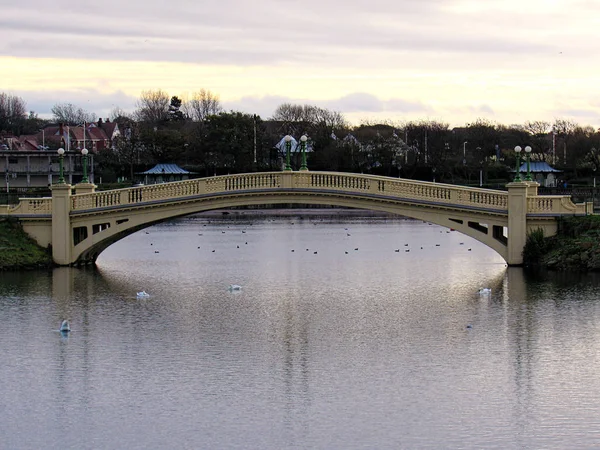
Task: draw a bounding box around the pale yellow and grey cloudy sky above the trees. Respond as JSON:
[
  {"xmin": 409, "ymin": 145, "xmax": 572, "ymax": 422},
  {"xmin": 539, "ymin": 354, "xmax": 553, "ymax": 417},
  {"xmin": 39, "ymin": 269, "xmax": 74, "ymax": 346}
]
[{"xmin": 0, "ymin": 0, "xmax": 600, "ymax": 127}]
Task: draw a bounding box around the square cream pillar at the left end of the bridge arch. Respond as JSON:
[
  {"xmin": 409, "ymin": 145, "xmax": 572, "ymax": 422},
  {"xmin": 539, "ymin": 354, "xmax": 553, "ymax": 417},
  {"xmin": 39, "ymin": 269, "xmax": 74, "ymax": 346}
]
[{"xmin": 52, "ymin": 184, "xmax": 72, "ymax": 266}]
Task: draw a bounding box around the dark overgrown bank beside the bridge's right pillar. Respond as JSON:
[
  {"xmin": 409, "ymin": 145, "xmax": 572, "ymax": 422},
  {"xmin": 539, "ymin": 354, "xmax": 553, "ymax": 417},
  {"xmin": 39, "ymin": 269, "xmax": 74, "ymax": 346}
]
[{"xmin": 523, "ymin": 216, "xmax": 600, "ymax": 272}]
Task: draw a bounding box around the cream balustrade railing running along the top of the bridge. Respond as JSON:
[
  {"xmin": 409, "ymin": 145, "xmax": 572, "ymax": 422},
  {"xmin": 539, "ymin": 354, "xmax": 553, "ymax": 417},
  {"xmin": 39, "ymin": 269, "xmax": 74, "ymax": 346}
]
[{"xmin": 0, "ymin": 171, "xmax": 586, "ymax": 215}]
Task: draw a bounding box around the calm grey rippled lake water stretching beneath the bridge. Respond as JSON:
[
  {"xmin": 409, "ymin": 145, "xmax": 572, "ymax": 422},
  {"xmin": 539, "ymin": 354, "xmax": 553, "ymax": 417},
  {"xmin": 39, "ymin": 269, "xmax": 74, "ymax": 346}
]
[{"xmin": 0, "ymin": 215, "xmax": 600, "ymax": 449}]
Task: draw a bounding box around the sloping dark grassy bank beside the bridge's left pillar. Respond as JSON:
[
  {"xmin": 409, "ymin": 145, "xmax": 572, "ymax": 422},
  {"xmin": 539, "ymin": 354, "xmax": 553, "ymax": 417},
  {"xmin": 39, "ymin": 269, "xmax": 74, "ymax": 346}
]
[{"xmin": 0, "ymin": 219, "xmax": 52, "ymax": 270}]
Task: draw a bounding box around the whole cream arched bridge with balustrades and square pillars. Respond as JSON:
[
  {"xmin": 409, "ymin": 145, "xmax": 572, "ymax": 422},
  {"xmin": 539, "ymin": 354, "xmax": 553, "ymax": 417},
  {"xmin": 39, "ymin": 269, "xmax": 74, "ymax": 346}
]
[{"xmin": 0, "ymin": 171, "xmax": 586, "ymax": 265}]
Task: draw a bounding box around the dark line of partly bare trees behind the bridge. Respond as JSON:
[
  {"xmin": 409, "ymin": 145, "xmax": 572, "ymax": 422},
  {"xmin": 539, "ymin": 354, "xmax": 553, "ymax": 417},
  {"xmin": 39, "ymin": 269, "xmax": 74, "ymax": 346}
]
[{"xmin": 0, "ymin": 89, "xmax": 600, "ymax": 182}]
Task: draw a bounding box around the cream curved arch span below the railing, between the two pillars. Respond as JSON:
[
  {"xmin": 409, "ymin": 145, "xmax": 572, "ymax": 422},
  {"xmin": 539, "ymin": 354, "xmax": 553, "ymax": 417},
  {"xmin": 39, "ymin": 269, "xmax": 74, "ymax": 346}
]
[{"xmin": 71, "ymin": 190, "xmax": 508, "ymax": 264}]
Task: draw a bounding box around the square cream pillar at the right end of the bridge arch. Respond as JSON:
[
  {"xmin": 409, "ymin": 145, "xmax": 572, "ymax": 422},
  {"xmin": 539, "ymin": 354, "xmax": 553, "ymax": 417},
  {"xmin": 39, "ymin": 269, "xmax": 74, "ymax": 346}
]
[{"xmin": 506, "ymin": 181, "xmax": 529, "ymax": 266}]
